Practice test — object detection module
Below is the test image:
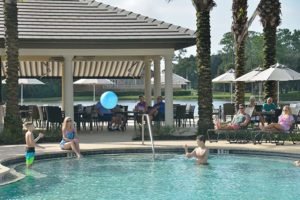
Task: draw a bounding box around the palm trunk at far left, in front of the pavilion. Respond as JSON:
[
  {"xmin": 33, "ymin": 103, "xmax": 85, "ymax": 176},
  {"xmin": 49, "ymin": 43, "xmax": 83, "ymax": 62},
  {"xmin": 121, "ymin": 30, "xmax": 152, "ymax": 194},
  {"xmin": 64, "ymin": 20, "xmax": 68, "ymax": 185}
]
[{"xmin": 4, "ymin": 0, "xmax": 23, "ymax": 143}]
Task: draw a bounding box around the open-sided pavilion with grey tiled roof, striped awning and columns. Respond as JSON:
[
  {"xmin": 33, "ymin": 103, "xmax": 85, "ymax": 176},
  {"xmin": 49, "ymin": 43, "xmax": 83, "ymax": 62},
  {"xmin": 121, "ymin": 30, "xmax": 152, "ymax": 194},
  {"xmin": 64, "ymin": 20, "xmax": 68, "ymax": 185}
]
[{"xmin": 0, "ymin": 0, "xmax": 196, "ymax": 125}]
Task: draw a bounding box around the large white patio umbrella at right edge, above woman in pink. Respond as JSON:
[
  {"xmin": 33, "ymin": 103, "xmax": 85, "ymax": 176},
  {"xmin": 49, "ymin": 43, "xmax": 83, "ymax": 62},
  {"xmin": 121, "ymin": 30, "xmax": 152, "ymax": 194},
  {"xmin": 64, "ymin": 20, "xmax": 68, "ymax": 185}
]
[{"xmin": 252, "ymin": 63, "xmax": 300, "ymax": 102}]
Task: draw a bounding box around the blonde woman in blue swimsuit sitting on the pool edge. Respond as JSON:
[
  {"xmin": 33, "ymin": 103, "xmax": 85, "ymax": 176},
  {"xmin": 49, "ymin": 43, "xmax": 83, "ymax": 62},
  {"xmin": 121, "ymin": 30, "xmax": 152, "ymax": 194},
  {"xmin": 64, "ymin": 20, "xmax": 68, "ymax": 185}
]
[{"xmin": 60, "ymin": 117, "xmax": 81, "ymax": 158}]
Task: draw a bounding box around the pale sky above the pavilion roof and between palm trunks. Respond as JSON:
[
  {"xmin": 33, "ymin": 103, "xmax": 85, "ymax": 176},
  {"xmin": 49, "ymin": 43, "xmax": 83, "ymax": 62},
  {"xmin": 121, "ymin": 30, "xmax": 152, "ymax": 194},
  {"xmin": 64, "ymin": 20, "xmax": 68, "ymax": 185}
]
[{"xmin": 97, "ymin": 0, "xmax": 300, "ymax": 56}]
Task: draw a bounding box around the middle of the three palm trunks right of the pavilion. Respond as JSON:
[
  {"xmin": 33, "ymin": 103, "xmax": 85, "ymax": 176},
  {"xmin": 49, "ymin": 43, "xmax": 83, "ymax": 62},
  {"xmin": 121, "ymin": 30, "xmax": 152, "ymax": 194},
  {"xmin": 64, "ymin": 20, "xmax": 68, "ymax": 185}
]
[{"xmin": 231, "ymin": 0, "xmax": 248, "ymax": 108}]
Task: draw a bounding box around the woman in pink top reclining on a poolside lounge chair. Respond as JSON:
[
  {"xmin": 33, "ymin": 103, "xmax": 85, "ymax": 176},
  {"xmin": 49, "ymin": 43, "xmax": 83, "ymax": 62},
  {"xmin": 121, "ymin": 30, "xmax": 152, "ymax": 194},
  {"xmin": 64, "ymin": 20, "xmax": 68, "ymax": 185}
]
[{"xmin": 260, "ymin": 106, "xmax": 294, "ymax": 132}]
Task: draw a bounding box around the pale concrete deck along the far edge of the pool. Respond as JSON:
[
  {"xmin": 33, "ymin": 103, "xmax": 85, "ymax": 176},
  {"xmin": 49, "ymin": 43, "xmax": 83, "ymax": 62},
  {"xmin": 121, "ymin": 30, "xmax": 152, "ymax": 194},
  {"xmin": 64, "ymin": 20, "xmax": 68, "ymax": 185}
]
[{"xmin": 0, "ymin": 127, "xmax": 300, "ymax": 164}]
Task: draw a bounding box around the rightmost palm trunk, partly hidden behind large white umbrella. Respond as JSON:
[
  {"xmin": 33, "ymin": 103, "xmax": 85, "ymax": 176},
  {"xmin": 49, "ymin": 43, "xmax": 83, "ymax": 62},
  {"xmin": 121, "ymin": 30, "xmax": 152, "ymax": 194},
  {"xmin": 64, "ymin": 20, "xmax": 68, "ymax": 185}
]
[{"xmin": 258, "ymin": 0, "xmax": 281, "ymax": 102}]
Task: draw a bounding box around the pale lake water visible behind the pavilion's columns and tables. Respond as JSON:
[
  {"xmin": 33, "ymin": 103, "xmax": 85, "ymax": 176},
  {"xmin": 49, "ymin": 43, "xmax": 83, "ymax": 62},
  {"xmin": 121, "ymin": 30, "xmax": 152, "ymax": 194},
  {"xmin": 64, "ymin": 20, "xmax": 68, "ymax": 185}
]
[{"xmin": 24, "ymin": 99, "xmax": 229, "ymax": 115}]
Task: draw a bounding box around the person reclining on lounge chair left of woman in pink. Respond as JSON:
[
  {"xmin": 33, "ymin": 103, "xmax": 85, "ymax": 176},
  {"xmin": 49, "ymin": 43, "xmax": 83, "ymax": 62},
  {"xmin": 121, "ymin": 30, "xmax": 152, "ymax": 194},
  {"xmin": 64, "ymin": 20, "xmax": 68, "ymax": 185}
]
[{"xmin": 216, "ymin": 104, "xmax": 250, "ymax": 130}]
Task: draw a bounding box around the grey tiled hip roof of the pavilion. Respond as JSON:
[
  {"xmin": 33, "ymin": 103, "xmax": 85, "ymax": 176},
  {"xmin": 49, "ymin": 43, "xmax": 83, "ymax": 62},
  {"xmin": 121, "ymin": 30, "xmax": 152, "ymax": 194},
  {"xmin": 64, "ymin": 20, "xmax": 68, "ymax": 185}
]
[{"xmin": 0, "ymin": 0, "xmax": 196, "ymax": 50}]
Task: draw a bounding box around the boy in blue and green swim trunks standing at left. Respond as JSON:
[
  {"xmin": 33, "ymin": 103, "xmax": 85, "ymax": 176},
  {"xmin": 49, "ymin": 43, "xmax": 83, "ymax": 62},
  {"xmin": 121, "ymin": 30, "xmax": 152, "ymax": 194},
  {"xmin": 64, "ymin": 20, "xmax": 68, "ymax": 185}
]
[{"xmin": 23, "ymin": 122, "xmax": 45, "ymax": 168}]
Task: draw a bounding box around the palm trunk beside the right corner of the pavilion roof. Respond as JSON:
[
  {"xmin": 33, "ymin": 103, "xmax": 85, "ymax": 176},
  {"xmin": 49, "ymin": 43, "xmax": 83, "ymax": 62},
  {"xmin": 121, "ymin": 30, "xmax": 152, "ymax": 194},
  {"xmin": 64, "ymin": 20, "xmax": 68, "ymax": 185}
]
[{"xmin": 192, "ymin": 0, "xmax": 216, "ymax": 134}]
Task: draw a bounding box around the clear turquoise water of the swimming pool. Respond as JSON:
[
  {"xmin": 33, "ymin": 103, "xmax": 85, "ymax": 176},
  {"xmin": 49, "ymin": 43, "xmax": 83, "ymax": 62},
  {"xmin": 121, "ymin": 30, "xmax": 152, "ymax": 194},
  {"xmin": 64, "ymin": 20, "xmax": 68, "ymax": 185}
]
[{"xmin": 0, "ymin": 154, "xmax": 300, "ymax": 200}]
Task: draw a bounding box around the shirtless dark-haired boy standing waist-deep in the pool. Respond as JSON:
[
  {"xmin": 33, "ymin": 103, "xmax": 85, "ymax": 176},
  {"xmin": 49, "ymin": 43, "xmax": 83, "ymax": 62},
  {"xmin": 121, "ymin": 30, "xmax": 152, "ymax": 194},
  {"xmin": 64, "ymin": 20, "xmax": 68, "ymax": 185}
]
[{"xmin": 184, "ymin": 135, "xmax": 209, "ymax": 165}]
